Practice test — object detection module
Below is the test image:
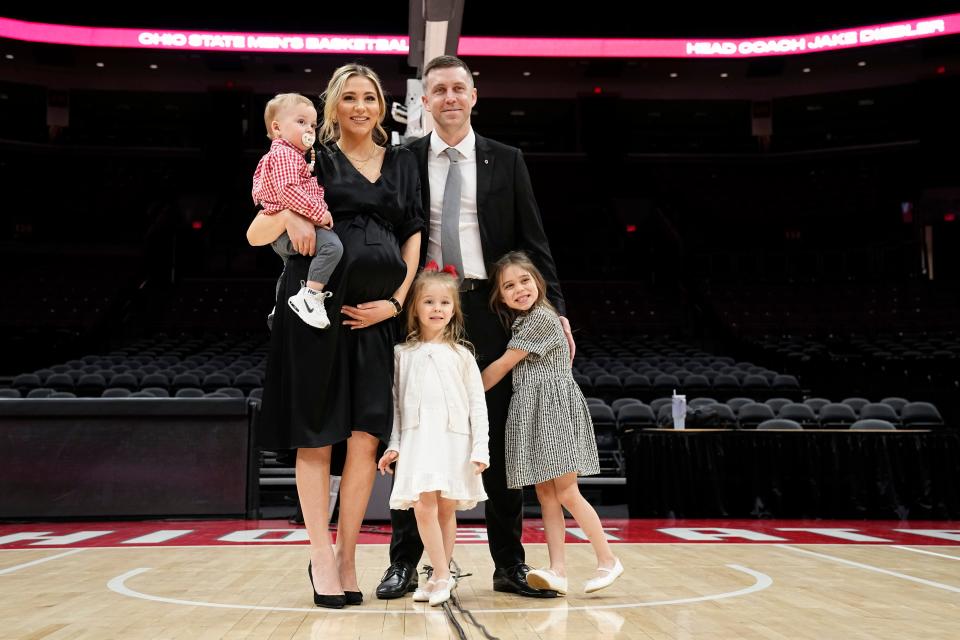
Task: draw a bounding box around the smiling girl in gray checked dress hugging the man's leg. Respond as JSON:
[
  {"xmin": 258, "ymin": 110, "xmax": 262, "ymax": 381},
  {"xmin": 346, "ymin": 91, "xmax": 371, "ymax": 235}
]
[{"xmin": 482, "ymin": 252, "xmax": 623, "ymax": 594}]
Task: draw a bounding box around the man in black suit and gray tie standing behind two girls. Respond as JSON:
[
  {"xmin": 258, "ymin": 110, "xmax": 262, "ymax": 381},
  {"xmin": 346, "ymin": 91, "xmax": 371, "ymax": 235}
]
[{"xmin": 377, "ymin": 56, "xmax": 574, "ymax": 598}]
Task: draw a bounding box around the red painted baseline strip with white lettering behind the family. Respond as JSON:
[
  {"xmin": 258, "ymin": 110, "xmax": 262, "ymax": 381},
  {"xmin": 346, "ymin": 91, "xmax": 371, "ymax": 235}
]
[{"xmin": 0, "ymin": 519, "xmax": 960, "ymax": 549}]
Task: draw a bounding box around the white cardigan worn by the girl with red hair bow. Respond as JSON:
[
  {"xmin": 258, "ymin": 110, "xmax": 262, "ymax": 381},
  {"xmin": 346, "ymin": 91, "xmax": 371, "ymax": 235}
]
[{"xmin": 387, "ymin": 343, "xmax": 490, "ymax": 466}]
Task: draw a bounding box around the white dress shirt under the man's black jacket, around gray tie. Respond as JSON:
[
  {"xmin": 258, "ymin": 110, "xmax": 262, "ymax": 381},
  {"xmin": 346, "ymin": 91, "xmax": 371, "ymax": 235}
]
[{"xmin": 427, "ymin": 127, "xmax": 487, "ymax": 280}]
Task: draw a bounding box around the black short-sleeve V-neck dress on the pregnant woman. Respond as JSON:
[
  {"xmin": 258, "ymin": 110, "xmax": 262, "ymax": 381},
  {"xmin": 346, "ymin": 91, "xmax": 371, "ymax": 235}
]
[{"xmin": 257, "ymin": 144, "xmax": 423, "ymax": 471}]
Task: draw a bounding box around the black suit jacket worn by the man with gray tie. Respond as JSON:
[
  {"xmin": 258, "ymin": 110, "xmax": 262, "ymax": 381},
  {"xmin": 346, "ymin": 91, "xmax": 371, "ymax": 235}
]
[{"xmin": 409, "ymin": 135, "xmax": 567, "ymax": 315}]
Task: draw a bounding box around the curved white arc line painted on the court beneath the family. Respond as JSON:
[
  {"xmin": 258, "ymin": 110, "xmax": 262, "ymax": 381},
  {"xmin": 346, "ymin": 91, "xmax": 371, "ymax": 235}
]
[{"xmin": 107, "ymin": 564, "xmax": 773, "ymax": 616}]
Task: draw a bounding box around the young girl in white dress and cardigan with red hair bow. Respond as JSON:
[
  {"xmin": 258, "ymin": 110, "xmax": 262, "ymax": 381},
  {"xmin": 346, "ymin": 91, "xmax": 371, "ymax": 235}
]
[{"xmin": 377, "ymin": 261, "xmax": 490, "ymax": 606}]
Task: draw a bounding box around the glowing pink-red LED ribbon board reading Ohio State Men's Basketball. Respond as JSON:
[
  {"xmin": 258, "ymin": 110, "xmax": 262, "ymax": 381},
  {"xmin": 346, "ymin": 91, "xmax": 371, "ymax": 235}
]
[{"xmin": 0, "ymin": 13, "xmax": 960, "ymax": 58}]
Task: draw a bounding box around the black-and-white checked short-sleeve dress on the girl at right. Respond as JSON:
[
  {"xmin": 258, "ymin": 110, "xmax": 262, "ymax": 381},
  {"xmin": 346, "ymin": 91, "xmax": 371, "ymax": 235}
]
[{"xmin": 505, "ymin": 305, "xmax": 600, "ymax": 489}]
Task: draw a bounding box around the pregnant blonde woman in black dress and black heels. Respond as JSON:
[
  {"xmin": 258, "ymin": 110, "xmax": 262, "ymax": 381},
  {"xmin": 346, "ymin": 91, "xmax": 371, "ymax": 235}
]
[{"xmin": 247, "ymin": 64, "xmax": 423, "ymax": 608}]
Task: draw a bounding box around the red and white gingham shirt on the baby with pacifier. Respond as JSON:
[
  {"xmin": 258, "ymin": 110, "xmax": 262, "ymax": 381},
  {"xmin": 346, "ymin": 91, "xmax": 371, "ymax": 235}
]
[{"xmin": 253, "ymin": 138, "xmax": 327, "ymax": 222}]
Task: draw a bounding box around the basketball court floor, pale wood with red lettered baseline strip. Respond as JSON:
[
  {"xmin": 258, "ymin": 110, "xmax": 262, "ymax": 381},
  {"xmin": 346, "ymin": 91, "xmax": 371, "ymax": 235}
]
[{"xmin": 0, "ymin": 520, "xmax": 960, "ymax": 640}]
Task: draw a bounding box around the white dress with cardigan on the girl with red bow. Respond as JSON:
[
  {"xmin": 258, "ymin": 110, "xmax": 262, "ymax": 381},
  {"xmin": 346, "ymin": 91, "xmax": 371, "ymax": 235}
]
[{"xmin": 387, "ymin": 342, "xmax": 490, "ymax": 510}]
